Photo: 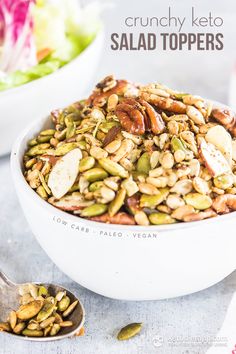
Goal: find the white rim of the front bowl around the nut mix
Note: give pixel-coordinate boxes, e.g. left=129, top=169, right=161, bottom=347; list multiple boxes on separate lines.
left=11, top=103, right=236, bottom=233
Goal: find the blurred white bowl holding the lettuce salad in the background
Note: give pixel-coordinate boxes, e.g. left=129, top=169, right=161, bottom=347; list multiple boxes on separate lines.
left=0, top=32, right=104, bottom=156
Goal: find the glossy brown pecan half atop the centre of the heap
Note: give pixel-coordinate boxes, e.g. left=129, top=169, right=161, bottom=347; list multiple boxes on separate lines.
left=115, top=98, right=165, bottom=135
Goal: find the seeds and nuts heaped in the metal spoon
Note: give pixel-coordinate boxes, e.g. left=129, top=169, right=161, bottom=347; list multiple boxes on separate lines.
left=0, top=284, right=79, bottom=337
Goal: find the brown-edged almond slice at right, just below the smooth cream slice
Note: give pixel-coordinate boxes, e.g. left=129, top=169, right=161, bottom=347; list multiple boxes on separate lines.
left=199, top=139, right=231, bottom=177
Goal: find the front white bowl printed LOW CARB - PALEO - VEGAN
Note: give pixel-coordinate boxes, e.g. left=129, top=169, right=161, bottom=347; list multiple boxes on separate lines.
left=11, top=118, right=236, bottom=300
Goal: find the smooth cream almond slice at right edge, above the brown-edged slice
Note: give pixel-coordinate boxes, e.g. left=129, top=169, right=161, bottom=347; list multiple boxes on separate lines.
left=205, top=125, right=233, bottom=165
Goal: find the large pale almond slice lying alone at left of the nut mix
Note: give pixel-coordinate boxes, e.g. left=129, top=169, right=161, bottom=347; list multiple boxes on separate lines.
left=48, top=148, right=82, bottom=199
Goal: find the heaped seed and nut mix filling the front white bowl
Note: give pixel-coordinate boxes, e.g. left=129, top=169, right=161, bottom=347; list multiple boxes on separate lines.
left=24, top=75, right=236, bottom=226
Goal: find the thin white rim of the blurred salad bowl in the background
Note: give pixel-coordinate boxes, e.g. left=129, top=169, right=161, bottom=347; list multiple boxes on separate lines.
left=0, top=28, right=104, bottom=98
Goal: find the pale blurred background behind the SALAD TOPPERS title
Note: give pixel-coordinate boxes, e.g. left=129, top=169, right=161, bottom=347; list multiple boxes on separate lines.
left=87, top=0, right=236, bottom=103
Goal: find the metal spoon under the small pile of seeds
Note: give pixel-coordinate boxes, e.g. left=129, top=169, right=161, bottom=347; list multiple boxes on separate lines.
left=0, top=271, right=85, bottom=342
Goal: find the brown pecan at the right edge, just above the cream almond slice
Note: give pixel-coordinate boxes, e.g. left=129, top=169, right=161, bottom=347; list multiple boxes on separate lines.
left=211, top=108, right=236, bottom=137
